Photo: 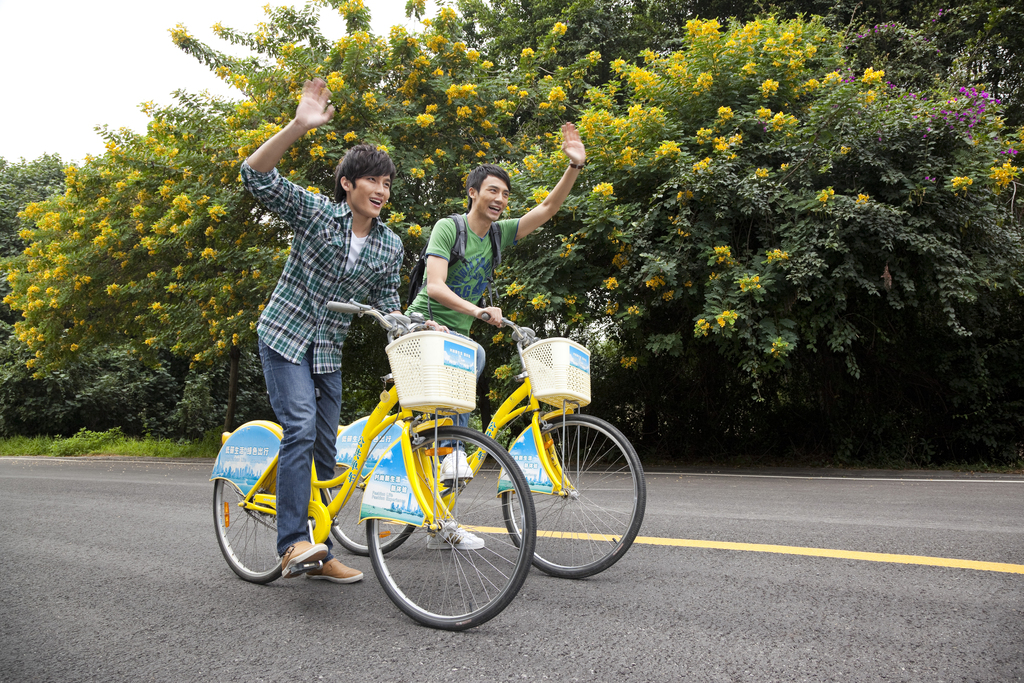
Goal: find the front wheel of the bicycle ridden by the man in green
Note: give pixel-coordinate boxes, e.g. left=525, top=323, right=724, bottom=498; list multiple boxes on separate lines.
left=503, top=415, right=647, bottom=579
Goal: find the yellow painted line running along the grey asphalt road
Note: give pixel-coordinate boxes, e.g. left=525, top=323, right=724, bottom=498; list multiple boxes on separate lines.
left=469, top=526, right=1024, bottom=573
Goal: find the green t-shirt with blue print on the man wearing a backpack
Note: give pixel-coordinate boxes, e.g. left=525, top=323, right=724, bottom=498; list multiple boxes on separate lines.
left=408, top=216, right=519, bottom=336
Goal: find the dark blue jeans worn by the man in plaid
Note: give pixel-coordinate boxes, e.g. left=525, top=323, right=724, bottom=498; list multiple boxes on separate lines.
left=259, top=341, right=341, bottom=561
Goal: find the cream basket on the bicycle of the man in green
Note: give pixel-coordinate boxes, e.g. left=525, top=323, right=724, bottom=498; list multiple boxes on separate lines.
left=522, top=337, right=590, bottom=408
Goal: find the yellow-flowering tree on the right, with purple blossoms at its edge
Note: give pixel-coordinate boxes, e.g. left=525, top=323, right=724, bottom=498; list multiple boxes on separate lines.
left=487, top=18, right=1024, bottom=462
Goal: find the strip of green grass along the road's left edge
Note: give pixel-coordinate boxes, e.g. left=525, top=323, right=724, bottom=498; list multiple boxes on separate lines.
left=0, top=428, right=220, bottom=458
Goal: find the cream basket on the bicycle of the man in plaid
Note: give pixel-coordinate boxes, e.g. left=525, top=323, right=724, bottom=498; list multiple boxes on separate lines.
left=385, top=331, right=476, bottom=413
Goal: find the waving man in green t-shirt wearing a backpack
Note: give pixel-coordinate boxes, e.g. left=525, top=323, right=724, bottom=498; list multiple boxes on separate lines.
left=409, top=123, right=587, bottom=489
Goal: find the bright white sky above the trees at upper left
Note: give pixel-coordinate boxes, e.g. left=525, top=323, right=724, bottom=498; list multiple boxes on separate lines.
left=0, top=0, right=435, bottom=162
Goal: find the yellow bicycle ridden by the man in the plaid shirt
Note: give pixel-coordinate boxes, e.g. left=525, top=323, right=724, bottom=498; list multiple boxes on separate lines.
left=211, top=302, right=537, bottom=631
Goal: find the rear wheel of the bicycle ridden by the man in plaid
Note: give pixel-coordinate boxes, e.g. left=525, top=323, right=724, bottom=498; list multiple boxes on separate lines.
left=213, top=479, right=281, bottom=584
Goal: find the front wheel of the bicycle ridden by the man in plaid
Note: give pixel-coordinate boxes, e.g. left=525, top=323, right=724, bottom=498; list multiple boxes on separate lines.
left=366, top=427, right=536, bottom=631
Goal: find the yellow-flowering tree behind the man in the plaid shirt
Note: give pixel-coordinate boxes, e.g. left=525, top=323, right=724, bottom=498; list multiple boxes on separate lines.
left=5, top=1, right=564, bottom=421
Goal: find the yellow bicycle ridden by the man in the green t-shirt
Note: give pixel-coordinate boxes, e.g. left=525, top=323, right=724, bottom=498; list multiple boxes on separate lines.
left=333, top=318, right=647, bottom=579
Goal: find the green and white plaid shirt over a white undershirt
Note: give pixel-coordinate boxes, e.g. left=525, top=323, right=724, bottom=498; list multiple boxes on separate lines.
left=242, top=163, right=404, bottom=374
